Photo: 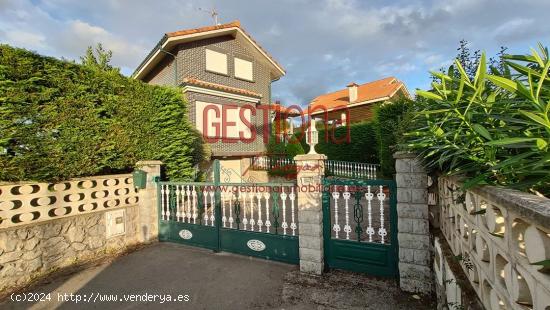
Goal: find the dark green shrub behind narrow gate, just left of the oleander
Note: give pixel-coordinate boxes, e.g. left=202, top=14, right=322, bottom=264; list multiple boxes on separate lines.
left=375, top=98, right=413, bottom=177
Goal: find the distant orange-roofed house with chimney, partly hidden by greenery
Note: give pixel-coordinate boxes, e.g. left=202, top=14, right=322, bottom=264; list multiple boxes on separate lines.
left=308, top=77, right=411, bottom=125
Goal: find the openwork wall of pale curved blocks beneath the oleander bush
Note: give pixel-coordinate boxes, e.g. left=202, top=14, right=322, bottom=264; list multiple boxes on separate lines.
left=440, top=177, right=550, bottom=310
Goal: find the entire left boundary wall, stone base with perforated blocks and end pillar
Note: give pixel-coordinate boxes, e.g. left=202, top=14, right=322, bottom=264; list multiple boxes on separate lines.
left=0, top=167, right=162, bottom=296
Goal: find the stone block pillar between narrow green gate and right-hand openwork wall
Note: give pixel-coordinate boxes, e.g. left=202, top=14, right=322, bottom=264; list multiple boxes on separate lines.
left=393, top=152, right=433, bottom=294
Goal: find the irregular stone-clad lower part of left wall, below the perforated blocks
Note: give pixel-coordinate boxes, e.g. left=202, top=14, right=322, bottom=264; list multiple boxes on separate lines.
left=0, top=206, right=139, bottom=294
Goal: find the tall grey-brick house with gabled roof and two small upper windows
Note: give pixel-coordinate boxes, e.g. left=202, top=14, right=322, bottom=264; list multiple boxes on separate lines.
left=133, top=21, right=285, bottom=182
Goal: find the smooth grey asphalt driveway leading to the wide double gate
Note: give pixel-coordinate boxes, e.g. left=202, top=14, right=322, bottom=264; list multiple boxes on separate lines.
left=0, top=243, right=297, bottom=309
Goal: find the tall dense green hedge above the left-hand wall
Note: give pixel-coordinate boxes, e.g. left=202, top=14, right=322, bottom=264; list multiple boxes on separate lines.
left=0, top=45, right=204, bottom=181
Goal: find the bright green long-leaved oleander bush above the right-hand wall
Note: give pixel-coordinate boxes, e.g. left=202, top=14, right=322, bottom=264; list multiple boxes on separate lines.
left=403, top=45, right=550, bottom=195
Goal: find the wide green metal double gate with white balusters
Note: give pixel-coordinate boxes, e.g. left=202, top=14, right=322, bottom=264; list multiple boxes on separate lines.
left=158, top=160, right=299, bottom=264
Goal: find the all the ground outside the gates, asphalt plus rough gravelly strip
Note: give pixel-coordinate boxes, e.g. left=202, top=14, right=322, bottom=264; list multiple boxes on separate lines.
left=0, top=243, right=434, bottom=310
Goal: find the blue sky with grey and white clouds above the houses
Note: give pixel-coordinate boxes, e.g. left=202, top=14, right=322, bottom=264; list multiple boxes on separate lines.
left=0, top=0, right=550, bottom=106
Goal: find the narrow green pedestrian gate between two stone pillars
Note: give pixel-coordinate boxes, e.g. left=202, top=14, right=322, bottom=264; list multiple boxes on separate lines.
left=323, top=178, right=399, bottom=277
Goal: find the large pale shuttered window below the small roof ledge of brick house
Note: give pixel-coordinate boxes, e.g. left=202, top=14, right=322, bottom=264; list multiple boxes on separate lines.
left=195, top=101, right=252, bottom=139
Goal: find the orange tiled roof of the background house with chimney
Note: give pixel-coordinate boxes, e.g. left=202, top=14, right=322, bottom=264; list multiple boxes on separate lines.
left=309, top=77, right=408, bottom=113
